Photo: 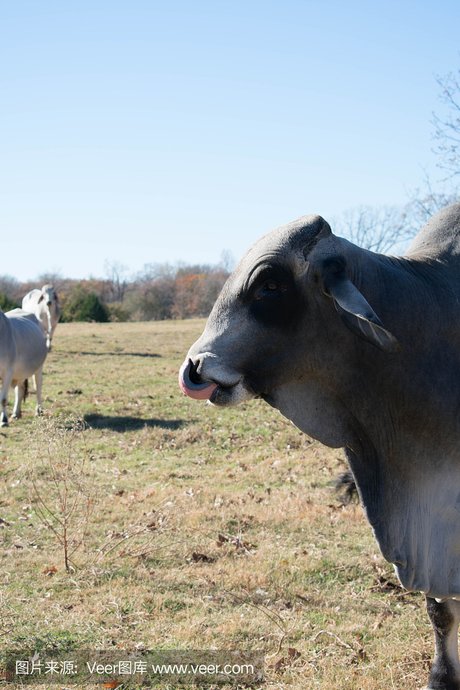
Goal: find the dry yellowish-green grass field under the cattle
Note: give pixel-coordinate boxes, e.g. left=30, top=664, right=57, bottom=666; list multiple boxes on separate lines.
left=0, top=321, right=432, bottom=690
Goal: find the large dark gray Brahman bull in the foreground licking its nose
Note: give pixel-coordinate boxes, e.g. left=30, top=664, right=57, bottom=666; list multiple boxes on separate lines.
left=179, top=204, right=460, bottom=690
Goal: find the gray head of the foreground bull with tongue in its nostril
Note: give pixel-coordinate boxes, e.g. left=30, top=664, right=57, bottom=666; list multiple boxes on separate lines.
left=179, top=216, right=397, bottom=445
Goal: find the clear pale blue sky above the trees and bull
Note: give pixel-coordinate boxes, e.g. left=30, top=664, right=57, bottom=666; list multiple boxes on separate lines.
left=0, top=0, right=460, bottom=279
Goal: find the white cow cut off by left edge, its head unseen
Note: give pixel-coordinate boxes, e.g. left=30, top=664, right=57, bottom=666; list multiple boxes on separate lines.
left=0, top=309, right=48, bottom=426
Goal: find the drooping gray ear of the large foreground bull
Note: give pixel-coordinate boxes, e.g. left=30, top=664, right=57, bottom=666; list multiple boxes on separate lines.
left=322, top=257, right=400, bottom=352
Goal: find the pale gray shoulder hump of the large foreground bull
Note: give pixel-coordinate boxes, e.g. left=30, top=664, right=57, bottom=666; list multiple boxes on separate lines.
left=407, top=203, right=460, bottom=261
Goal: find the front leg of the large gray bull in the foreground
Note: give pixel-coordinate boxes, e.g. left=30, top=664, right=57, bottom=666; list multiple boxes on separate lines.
left=426, top=597, right=460, bottom=690
